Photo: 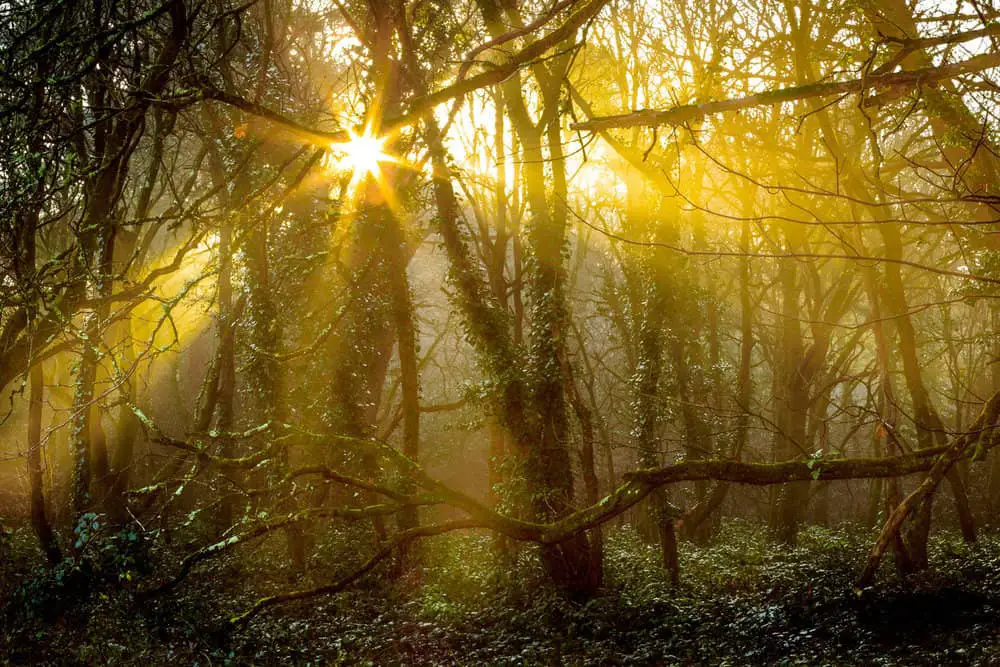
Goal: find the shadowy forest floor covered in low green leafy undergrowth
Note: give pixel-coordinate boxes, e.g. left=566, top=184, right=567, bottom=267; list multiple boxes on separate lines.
left=0, top=522, right=1000, bottom=665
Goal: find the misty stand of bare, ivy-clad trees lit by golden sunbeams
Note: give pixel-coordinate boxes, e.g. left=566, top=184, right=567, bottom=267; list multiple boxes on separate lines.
left=0, top=0, right=1000, bottom=622
